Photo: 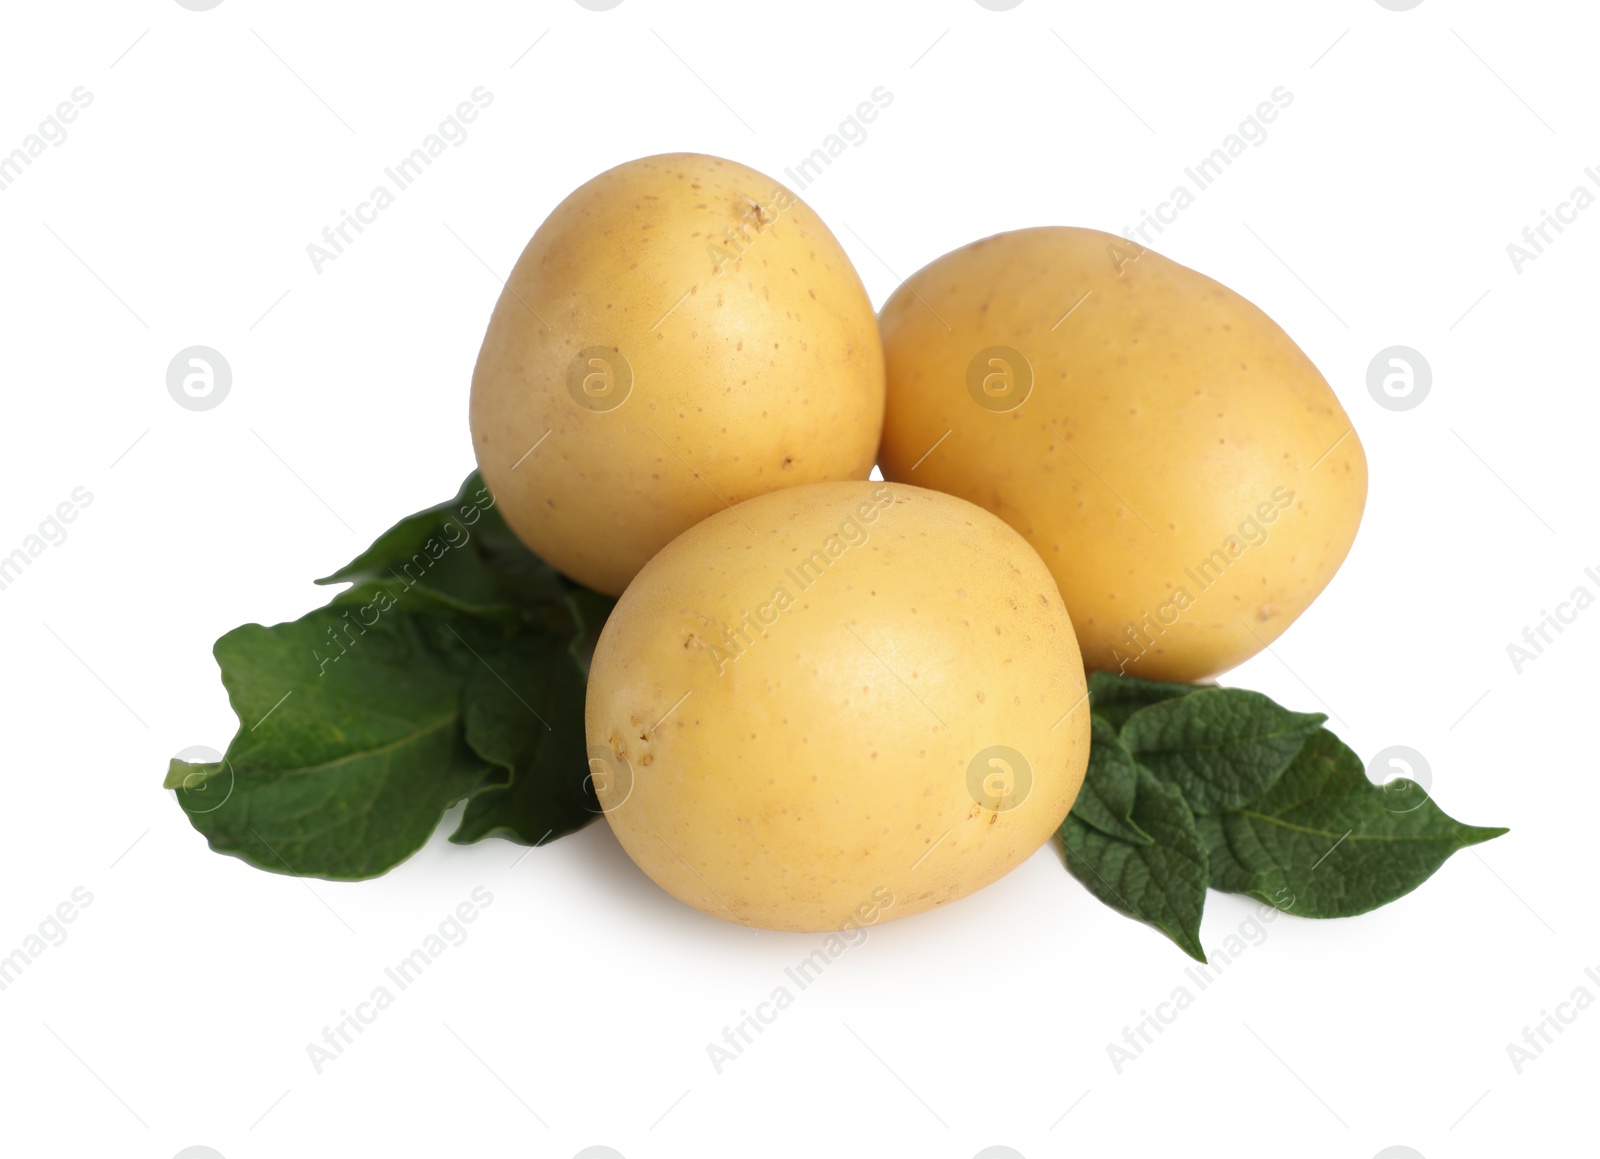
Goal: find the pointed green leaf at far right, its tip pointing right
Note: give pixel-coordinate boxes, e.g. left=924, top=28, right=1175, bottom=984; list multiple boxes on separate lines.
left=1202, top=728, right=1506, bottom=917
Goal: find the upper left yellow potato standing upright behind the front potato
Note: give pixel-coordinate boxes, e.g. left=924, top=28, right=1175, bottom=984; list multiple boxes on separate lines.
left=472, top=154, right=883, bottom=596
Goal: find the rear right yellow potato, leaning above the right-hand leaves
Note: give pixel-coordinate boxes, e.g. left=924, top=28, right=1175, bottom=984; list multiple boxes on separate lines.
left=880, top=227, right=1366, bottom=680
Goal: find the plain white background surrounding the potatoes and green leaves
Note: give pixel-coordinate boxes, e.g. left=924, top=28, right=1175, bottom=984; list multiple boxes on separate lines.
left=0, top=0, right=1600, bottom=1159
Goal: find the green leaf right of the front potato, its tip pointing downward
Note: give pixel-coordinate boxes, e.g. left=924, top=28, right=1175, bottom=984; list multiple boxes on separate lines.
left=1061, top=768, right=1208, bottom=962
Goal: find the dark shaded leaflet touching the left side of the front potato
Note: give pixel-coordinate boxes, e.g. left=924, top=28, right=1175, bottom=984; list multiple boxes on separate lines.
left=451, top=634, right=600, bottom=845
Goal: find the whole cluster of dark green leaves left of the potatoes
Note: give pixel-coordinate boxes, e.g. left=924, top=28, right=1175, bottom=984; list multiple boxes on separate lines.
left=166, top=474, right=614, bottom=879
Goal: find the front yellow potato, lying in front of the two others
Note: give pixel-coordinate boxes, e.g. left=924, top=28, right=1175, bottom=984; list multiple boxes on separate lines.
left=586, top=482, right=1090, bottom=930
